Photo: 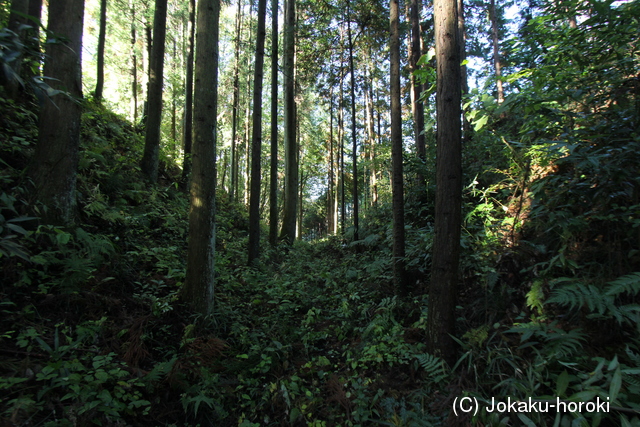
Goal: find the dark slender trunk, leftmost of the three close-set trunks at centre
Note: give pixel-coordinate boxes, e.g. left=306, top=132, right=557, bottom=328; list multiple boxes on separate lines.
left=249, top=0, right=267, bottom=265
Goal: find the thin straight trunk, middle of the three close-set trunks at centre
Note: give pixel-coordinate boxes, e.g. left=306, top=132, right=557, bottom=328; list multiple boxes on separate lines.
left=269, top=0, right=278, bottom=246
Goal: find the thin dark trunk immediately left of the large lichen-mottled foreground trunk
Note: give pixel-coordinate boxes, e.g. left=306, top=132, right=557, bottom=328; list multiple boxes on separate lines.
left=182, top=0, right=196, bottom=188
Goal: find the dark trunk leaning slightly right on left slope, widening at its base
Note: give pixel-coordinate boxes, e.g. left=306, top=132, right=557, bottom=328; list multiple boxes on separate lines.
left=140, top=0, right=167, bottom=184
